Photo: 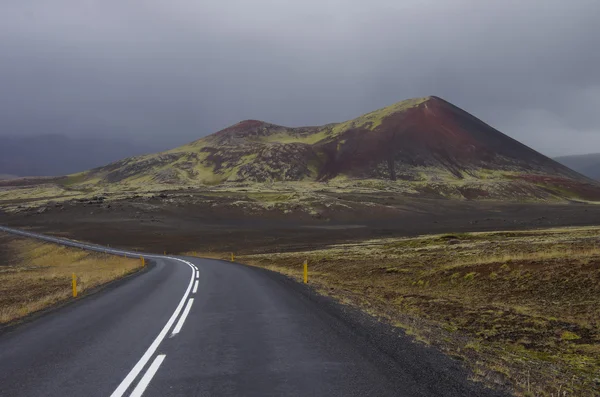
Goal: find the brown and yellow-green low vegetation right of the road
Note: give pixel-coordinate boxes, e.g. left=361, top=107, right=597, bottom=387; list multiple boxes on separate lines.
left=202, top=228, right=600, bottom=396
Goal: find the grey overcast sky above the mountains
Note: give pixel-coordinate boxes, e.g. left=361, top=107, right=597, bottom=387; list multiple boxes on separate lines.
left=0, top=0, right=600, bottom=155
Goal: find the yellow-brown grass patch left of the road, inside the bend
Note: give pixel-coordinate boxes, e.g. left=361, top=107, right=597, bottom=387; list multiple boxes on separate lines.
left=0, top=233, right=141, bottom=324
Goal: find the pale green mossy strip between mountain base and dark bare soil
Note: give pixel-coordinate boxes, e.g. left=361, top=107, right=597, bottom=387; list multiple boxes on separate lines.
left=0, top=173, right=598, bottom=218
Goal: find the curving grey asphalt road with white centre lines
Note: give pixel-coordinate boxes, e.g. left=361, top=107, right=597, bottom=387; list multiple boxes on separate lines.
left=0, top=227, right=506, bottom=397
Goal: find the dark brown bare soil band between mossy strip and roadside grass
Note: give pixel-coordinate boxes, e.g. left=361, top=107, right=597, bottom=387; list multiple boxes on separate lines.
left=0, top=192, right=600, bottom=253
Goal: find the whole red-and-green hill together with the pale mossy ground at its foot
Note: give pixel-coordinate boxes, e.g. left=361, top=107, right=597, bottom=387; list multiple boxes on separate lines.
left=1, top=96, right=600, bottom=200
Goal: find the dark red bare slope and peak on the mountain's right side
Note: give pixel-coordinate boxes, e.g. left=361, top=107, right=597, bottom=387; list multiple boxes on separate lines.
left=320, top=97, right=585, bottom=180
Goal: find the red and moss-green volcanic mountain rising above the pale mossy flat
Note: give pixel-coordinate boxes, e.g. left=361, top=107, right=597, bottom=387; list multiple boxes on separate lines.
left=74, top=96, right=591, bottom=184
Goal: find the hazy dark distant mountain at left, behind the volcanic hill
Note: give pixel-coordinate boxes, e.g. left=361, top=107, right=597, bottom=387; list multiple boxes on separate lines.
left=0, top=134, right=162, bottom=176
